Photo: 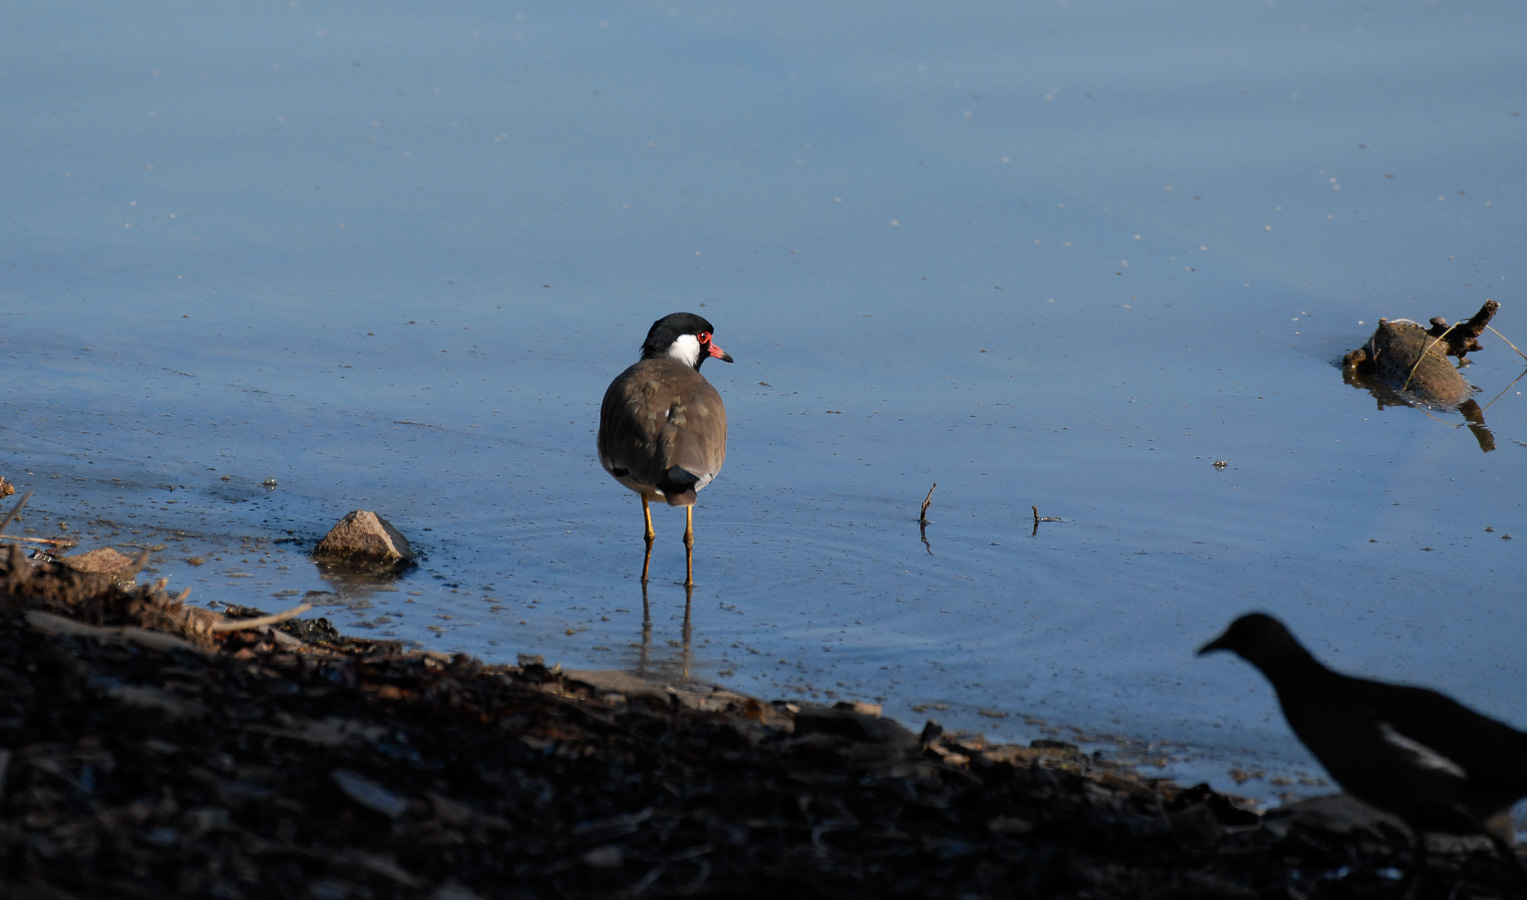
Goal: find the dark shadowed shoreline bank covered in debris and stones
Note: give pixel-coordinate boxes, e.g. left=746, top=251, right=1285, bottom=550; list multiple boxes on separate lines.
left=0, top=549, right=1512, bottom=900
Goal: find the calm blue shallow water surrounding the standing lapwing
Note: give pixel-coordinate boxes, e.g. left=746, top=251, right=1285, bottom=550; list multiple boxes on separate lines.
left=0, top=3, right=1527, bottom=795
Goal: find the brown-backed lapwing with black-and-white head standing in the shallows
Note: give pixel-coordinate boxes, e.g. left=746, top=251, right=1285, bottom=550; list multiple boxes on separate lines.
left=599, top=313, right=731, bottom=587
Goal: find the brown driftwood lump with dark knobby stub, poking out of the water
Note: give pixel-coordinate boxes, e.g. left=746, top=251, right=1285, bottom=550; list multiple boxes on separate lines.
left=1342, top=299, right=1501, bottom=406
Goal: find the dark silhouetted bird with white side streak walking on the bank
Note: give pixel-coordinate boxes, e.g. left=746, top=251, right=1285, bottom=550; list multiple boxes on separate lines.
left=1199, top=613, right=1527, bottom=888
